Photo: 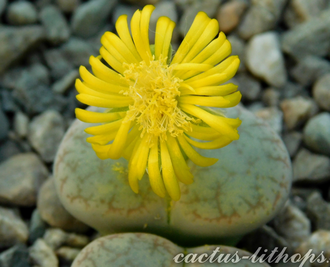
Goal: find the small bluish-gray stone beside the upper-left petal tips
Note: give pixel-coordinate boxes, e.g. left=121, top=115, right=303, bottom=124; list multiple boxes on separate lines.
left=61, top=37, right=98, bottom=67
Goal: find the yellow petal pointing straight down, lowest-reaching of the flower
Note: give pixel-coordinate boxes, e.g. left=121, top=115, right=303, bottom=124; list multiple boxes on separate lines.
left=160, top=142, right=181, bottom=201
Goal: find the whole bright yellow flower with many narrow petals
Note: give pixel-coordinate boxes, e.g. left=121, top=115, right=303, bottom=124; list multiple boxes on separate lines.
left=76, top=5, right=241, bottom=200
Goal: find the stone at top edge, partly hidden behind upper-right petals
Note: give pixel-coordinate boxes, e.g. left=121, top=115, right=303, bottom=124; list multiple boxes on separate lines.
left=179, top=0, right=222, bottom=36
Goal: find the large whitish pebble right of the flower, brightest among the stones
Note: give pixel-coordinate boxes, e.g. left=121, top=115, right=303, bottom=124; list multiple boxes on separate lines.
left=246, top=32, right=287, bottom=87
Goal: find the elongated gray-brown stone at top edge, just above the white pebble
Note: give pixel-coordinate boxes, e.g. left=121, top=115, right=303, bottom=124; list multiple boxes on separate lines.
left=238, top=0, right=287, bottom=39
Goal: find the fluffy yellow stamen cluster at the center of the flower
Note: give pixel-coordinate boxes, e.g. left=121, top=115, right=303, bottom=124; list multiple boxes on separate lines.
left=124, top=59, right=193, bottom=142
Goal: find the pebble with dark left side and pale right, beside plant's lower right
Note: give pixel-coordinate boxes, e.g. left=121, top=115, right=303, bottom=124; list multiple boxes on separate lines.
left=274, top=203, right=311, bottom=248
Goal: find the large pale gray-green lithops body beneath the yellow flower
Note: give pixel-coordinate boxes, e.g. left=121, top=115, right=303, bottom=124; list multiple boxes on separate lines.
left=54, top=104, right=292, bottom=245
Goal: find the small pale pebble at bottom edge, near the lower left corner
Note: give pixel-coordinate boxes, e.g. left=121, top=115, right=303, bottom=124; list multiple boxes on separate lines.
left=30, top=238, right=59, bottom=267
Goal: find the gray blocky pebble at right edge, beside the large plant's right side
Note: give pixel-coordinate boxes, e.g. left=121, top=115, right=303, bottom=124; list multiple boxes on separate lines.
left=293, top=148, right=330, bottom=183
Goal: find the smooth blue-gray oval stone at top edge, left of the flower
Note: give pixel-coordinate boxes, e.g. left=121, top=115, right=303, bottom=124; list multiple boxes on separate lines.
left=71, top=0, right=117, bottom=38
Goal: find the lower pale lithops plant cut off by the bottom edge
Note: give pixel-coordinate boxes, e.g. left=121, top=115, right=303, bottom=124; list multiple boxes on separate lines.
left=72, top=233, right=269, bottom=267
